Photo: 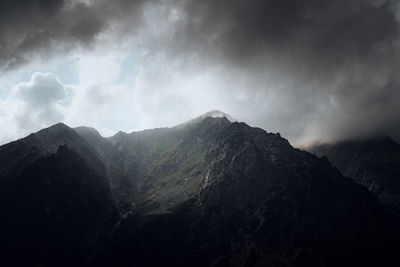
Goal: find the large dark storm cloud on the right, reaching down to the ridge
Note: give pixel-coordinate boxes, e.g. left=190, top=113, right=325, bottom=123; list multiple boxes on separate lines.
left=163, top=0, right=400, bottom=144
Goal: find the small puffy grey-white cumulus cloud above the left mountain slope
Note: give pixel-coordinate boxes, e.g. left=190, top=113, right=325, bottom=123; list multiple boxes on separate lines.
left=0, top=72, right=75, bottom=143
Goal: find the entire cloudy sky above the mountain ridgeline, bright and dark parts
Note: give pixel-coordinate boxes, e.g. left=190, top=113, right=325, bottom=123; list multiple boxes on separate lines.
left=0, top=0, right=400, bottom=146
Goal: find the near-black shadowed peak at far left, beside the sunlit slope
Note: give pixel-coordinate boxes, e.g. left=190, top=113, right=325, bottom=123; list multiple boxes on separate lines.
left=0, top=125, right=119, bottom=266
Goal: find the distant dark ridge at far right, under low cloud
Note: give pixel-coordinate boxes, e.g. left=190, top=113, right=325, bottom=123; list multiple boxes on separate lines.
left=311, top=137, right=400, bottom=215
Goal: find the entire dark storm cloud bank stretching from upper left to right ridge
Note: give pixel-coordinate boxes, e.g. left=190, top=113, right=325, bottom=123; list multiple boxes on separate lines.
left=0, top=0, right=400, bottom=142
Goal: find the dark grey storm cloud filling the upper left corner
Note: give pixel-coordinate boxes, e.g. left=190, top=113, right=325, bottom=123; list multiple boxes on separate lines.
left=0, top=0, right=148, bottom=70
